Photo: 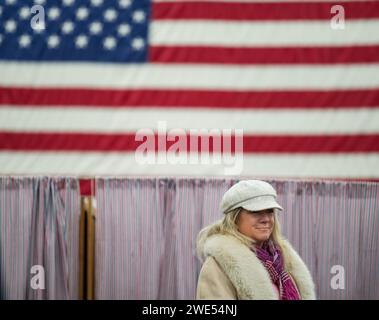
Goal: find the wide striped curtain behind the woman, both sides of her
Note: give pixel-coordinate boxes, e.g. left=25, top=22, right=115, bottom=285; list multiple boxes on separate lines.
left=95, top=178, right=379, bottom=299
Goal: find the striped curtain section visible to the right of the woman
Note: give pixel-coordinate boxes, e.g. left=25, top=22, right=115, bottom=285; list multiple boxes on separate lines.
left=270, top=181, right=379, bottom=300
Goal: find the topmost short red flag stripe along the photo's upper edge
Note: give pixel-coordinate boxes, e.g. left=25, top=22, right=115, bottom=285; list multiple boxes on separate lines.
left=152, top=1, right=379, bottom=20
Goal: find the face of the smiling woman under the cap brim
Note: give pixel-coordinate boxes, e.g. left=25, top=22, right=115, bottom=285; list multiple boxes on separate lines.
left=237, top=209, right=275, bottom=245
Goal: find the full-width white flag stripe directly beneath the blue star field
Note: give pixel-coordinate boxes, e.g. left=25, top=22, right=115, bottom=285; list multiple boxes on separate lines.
left=0, top=62, right=379, bottom=90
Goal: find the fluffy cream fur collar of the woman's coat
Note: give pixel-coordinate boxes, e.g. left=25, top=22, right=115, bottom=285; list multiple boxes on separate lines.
left=204, top=234, right=315, bottom=300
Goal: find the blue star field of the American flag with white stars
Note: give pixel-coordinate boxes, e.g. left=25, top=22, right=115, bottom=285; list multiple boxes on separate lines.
left=0, top=0, right=151, bottom=63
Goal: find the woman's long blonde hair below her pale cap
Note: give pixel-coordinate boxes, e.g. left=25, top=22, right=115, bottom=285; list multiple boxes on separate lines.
left=197, top=208, right=284, bottom=260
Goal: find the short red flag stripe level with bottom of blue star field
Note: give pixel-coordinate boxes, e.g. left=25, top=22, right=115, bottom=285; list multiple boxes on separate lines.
left=150, top=46, right=379, bottom=64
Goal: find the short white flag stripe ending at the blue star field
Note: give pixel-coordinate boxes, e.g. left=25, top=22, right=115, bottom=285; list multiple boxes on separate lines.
left=150, top=16, right=379, bottom=47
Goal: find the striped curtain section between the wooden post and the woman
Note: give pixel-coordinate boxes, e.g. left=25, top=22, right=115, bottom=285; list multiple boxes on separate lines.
left=95, top=179, right=230, bottom=299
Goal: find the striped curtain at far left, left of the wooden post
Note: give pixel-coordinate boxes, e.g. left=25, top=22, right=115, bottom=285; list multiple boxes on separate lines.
left=0, top=177, right=80, bottom=300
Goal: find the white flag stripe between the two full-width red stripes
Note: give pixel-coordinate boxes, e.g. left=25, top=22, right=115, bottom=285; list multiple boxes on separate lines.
left=0, top=106, right=379, bottom=135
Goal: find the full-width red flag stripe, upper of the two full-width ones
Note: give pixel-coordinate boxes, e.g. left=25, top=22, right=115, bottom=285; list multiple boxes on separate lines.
left=0, top=87, right=379, bottom=109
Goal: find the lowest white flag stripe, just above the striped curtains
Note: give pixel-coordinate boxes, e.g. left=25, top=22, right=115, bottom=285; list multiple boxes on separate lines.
left=0, top=152, right=379, bottom=178
